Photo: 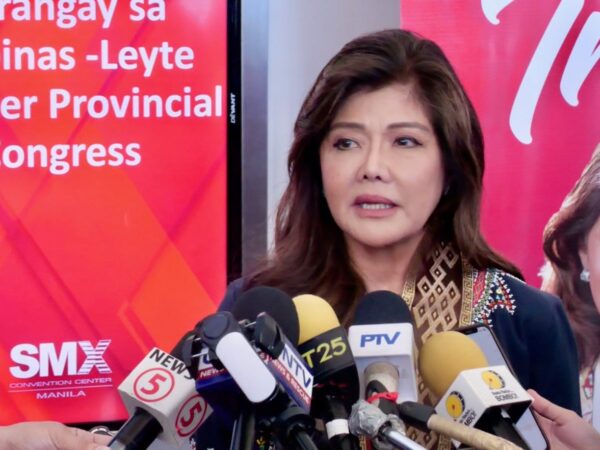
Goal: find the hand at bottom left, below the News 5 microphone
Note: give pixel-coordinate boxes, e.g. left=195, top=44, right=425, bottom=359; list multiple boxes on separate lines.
left=0, top=422, right=110, bottom=450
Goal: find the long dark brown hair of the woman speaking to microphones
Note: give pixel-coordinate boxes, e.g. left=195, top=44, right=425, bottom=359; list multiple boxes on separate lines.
left=249, top=30, right=520, bottom=318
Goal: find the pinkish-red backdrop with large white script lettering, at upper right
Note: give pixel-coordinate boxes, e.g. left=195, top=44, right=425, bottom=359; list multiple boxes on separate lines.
left=401, top=0, right=600, bottom=285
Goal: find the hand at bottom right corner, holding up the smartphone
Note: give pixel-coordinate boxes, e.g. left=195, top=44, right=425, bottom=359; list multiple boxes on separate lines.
left=527, top=389, right=600, bottom=450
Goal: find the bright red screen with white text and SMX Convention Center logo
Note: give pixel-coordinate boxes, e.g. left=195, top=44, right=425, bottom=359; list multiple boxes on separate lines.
left=0, top=0, right=227, bottom=424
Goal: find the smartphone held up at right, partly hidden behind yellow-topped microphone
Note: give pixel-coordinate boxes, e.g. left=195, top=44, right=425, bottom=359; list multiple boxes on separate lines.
left=457, top=324, right=550, bottom=450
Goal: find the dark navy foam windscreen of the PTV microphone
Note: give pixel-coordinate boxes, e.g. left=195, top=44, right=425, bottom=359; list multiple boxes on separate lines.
left=352, top=291, right=412, bottom=325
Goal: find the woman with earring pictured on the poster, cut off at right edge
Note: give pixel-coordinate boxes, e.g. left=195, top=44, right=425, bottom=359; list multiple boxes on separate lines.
left=542, top=146, right=600, bottom=430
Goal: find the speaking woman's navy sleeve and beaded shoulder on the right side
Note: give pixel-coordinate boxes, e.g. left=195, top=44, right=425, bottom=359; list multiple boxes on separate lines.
left=473, top=269, right=580, bottom=413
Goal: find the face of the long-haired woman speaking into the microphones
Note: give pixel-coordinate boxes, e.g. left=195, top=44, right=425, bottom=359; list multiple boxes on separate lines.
left=320, top=83, right=444, bottom=253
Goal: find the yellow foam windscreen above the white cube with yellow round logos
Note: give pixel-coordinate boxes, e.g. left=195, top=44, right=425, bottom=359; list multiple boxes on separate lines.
left=419, top=331, right=489, bottom=397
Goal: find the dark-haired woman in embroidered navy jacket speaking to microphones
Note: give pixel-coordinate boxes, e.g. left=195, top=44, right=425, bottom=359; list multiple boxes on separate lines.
left=221, top=30, right=579, bottom=448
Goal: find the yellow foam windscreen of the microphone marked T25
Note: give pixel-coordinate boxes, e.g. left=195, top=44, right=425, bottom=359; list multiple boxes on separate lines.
left=292, top=294, right=340, bottom=345
